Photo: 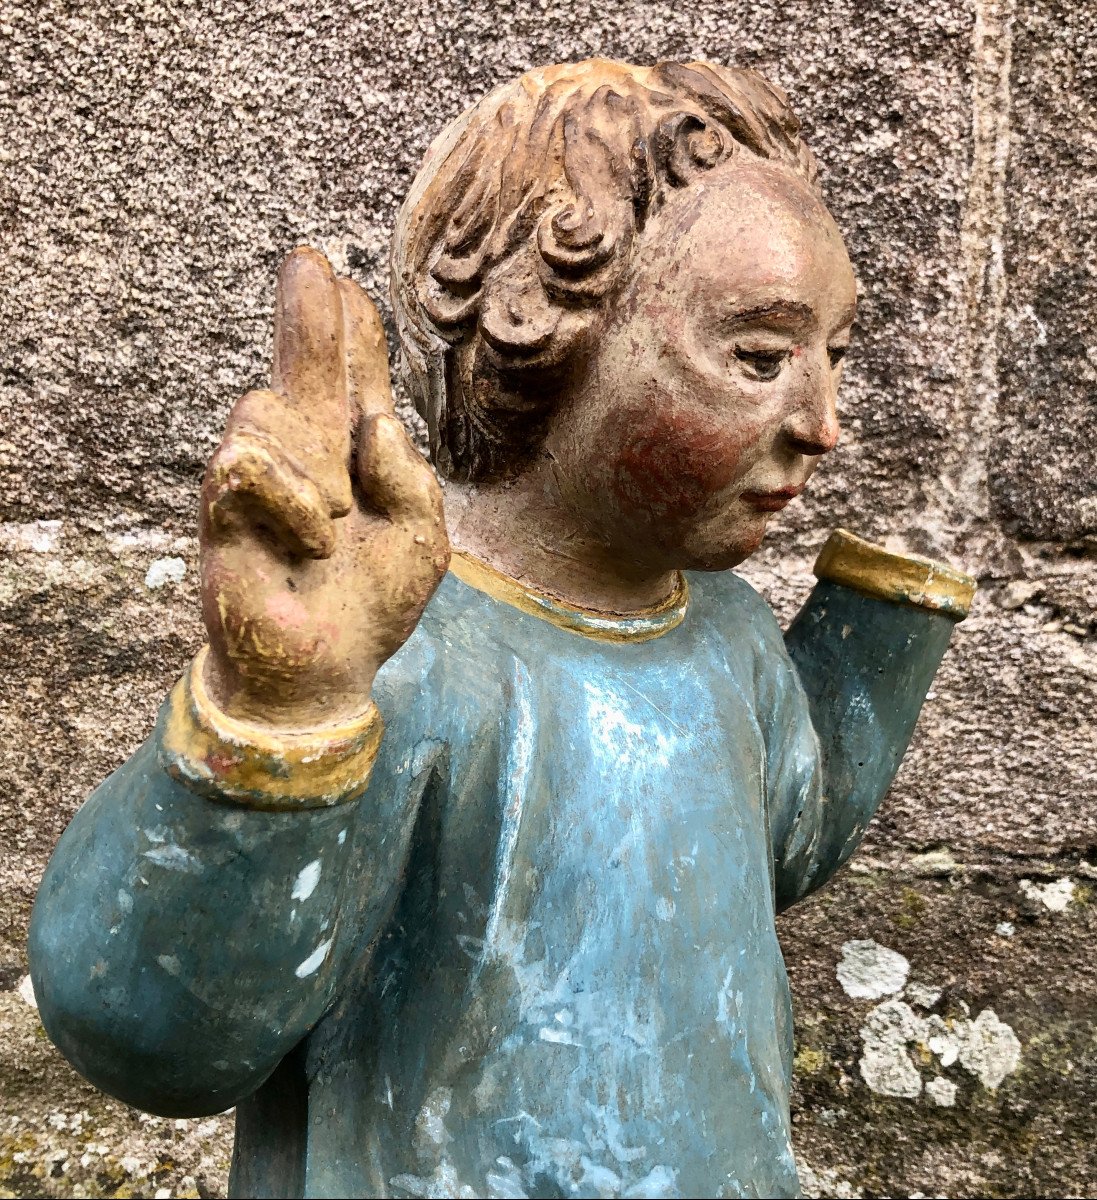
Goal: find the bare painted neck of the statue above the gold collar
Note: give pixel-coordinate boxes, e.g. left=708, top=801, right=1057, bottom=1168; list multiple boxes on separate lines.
left=445, top=462, right=677, bottom=613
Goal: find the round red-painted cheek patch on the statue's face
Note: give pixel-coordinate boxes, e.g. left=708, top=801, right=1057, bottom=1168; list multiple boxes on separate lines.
left=604, top=397, right=750, bottom=516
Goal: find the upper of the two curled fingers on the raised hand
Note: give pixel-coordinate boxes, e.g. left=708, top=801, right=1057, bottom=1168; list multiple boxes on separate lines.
left=224, top=390, right=353, bottom=517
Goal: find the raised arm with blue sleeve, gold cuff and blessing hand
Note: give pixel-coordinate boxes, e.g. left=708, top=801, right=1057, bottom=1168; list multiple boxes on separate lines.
left=29, top=250, right=448, bottom=1115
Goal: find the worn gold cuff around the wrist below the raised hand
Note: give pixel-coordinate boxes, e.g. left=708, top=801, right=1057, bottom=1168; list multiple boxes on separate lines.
left=160, top=647, right=384, bottom=811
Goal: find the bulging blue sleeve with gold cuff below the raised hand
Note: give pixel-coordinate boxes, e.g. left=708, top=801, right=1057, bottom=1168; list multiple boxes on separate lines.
left=29, top=647, right=430, bottom=1116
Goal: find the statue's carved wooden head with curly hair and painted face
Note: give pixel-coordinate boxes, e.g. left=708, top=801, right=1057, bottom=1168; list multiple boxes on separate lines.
left=392, top=59, right=856, bottom=566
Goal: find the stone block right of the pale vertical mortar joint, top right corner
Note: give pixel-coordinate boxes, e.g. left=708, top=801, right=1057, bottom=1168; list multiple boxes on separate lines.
left=991, top=4, right=1097, bottom=540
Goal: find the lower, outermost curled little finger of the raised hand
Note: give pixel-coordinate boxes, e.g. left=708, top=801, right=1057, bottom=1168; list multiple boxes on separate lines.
left=203, top=433, right=335, bottom=558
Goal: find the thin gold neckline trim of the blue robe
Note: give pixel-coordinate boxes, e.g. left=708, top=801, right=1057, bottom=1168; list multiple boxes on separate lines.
left=450, top=551, right=689, bottom=642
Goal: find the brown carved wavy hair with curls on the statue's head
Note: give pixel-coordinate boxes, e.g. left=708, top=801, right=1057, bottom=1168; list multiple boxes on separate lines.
left=392, top=59, right=816, bottom=480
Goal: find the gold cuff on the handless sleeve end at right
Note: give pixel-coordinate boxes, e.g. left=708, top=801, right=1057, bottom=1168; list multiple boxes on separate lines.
left=815, top=529, right=978, bottom=620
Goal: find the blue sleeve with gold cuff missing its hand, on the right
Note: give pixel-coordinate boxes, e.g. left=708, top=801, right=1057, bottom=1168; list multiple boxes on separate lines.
left=767, top=530, right=976, bottom=908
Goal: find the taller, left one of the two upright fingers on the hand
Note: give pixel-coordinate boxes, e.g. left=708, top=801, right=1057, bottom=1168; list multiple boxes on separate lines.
left=271, top=246, right=349, bottom=432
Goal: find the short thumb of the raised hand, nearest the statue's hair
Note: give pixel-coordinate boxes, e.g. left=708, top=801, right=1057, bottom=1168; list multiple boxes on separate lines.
left=358, top=413, right=443, bottom=526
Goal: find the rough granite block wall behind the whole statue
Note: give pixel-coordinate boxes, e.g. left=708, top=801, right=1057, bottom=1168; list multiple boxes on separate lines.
left=0, top=0, right=1097, bottom=1196
